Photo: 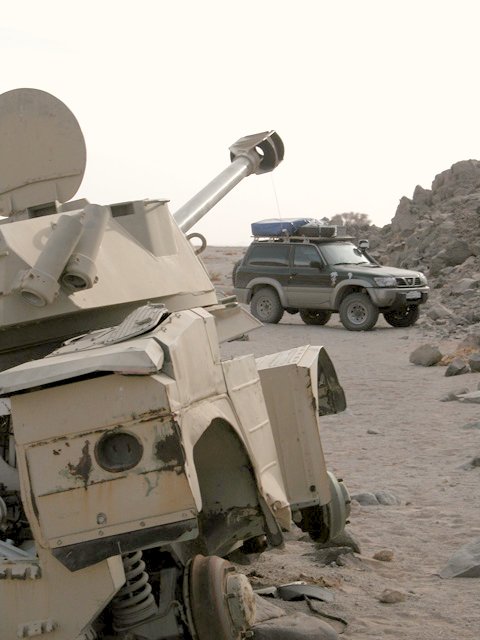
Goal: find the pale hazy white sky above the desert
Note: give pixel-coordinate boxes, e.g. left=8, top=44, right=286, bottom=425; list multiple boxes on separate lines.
left=0, top=0, right=480, bottom=245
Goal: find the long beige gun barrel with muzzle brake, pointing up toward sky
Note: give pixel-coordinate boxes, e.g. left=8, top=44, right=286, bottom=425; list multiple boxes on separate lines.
left=173, top=131, right=284, bottom=233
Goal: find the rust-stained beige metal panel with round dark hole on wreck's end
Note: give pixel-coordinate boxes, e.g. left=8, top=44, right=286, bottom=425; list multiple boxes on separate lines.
left=20, top=419, right=196, bottom=547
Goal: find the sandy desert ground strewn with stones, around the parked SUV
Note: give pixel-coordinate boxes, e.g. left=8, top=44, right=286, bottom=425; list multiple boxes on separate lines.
left=202, top=247, right=480, bottom=640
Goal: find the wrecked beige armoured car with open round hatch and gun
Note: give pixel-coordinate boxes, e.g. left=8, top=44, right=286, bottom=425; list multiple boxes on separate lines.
left=0, top=89, right=349, bottom=640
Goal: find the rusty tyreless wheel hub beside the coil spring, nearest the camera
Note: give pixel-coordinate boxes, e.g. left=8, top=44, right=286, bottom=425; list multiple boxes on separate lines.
left=184, top=555, right=255, bottom=640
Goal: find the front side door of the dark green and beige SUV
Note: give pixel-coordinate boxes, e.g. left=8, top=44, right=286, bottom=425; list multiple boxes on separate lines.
left=285, top=244, right=332, bottom=309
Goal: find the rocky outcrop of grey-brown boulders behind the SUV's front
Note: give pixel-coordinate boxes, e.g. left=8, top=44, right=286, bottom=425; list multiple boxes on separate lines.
left=370, top=160, right=480, bottom=334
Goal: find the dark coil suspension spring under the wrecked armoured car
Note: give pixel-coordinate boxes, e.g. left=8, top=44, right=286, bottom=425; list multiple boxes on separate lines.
left=112, top=551, right=158, bottom=631
